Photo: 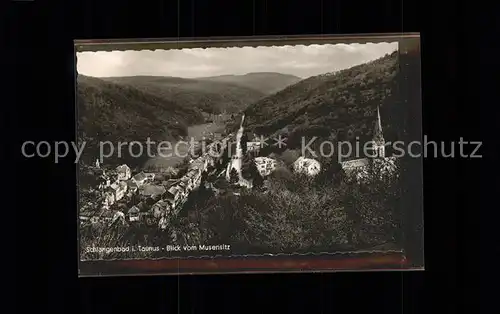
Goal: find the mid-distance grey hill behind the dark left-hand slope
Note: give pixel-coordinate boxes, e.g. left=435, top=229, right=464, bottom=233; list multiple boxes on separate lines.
left=102, top=76, right=266, bottom=114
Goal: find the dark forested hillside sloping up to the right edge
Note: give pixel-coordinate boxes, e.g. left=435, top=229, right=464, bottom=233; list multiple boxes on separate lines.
left=238, top=52, right=401, bottom=153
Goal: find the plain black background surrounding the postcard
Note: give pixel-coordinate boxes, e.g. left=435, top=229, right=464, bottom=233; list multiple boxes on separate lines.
left=7, top=0, right=482, bottom=313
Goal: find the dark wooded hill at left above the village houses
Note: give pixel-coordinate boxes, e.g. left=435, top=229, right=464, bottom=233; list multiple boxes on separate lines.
left=77, top=75, right=203, bottom=167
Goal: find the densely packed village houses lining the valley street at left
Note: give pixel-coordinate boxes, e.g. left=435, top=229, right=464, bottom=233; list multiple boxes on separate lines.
left=76, top=113, right=286, bottom=229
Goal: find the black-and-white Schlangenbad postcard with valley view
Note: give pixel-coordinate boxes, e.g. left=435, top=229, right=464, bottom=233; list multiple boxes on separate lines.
left=75, top=34, right=424, bottom=276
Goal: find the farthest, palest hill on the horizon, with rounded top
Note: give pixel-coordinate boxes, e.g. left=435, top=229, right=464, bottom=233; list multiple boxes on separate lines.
left=199, top=72, right=301, bottom=95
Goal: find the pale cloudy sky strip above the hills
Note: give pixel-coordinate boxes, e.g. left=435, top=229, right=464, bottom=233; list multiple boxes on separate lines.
left=77, top=42, right=398, bottom=78
